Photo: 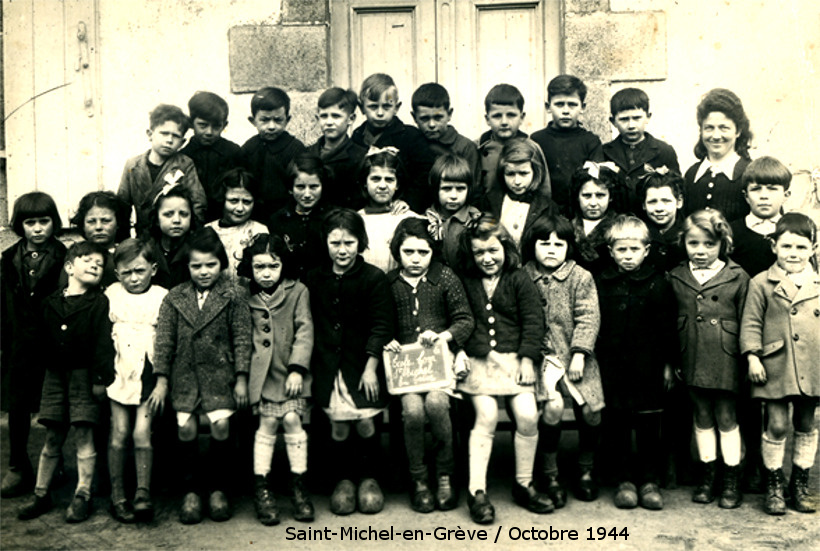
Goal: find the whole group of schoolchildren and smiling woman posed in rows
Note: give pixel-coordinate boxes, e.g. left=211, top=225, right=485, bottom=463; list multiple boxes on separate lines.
left=2, top=74, right=820, bottom=525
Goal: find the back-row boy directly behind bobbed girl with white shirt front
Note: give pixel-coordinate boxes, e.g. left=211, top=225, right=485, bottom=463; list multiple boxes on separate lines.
left=477, top=84, right=552, bottom=197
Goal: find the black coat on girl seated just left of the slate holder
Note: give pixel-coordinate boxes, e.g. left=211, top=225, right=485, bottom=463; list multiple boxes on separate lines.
left=305, top=256, right=395, bottom=408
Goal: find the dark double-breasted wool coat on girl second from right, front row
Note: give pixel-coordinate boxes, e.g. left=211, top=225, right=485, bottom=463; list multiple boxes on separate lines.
left=669, top=260, right=749, bottom=392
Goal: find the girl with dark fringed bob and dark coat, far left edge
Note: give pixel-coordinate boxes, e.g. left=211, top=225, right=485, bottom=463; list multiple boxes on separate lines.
left=0, top=191, right=66, bottom=497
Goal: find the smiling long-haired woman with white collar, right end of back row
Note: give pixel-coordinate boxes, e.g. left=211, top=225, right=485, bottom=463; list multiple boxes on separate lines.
left=683, top=88, right=752, bottom=220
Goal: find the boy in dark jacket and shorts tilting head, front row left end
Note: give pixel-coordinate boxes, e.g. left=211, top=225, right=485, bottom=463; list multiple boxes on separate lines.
left=17, top=241, right=115, bottom=523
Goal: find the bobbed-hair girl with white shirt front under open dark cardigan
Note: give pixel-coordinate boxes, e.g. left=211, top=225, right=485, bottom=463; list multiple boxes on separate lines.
left=480, top=139, right=556, bottom=246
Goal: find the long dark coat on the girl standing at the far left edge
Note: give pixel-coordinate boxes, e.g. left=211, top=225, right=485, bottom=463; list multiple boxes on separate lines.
left=0, top=238, right=66, bottom=412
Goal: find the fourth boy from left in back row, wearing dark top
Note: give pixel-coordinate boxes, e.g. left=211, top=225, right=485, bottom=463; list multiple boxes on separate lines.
left=308, top=87, right=367, bottom=209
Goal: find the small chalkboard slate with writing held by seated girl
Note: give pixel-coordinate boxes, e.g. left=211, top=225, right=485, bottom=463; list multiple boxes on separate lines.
left=384, top=340, right=453, bottom=394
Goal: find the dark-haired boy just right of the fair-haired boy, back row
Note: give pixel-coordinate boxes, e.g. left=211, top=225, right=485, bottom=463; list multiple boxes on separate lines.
left=410, top=82, right=481, bottom=183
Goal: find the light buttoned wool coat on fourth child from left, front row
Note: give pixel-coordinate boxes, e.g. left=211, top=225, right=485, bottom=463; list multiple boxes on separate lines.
left=248, top=279, right=313, bottom=404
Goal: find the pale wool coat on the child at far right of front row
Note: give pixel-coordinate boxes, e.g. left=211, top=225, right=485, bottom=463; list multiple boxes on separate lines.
left=740, top=264, right=820, bottom=400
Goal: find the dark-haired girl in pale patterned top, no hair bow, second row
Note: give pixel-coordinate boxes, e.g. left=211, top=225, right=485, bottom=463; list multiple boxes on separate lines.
left=205, top=168, right=268, bottom=282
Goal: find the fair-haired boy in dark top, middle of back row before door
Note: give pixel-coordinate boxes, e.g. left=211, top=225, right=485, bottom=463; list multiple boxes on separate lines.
left=351, top=73, right=435, bottom=212
